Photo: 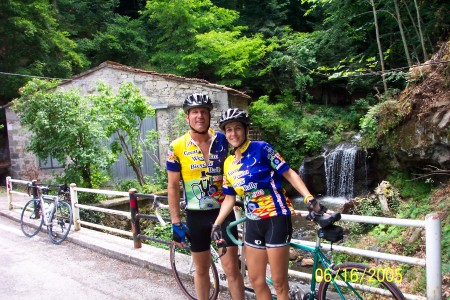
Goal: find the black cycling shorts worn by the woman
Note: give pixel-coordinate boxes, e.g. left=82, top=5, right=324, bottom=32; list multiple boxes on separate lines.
left=245, top=215, right=292, bottom=249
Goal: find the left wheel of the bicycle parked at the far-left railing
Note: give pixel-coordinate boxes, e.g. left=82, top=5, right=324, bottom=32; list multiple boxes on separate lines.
left=20, top=199, right=44, bottom=237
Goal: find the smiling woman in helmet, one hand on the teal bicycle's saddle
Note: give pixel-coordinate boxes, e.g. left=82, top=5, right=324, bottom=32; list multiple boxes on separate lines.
left=211, top=108, right=320, bottom=300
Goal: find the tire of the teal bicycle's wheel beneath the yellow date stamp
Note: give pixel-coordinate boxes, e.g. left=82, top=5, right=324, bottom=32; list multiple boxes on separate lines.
left=318, top=263, right=405, bottom=300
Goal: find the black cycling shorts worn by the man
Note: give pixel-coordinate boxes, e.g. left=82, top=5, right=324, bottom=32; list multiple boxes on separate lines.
left=186, top=209, right=238, bottom=252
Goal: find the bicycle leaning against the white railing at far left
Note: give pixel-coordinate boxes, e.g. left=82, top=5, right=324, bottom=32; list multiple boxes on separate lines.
left=20, top=182, right=73, bottom=244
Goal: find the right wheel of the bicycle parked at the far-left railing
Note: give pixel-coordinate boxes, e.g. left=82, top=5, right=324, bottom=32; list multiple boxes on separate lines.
left=47, top=201, right=73, bottom=244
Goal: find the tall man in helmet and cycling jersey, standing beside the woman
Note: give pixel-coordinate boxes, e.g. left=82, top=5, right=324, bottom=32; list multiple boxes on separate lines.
left=166, top=94, right=244, bottom=299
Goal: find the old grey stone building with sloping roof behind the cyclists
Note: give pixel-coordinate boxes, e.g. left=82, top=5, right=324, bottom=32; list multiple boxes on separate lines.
left=6, top=61, right=250, bottom=180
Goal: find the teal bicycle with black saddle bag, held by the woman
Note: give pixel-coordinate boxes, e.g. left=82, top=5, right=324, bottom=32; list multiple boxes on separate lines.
left=226, top=211, right=405, bottom=300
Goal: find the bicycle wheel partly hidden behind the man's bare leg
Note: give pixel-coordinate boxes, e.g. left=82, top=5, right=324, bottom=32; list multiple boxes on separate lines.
left=170, top=243, right=219, bottom=300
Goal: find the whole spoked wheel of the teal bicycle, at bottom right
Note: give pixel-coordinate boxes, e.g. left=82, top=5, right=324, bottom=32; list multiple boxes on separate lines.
left=318, top=263, right=405, bottom=300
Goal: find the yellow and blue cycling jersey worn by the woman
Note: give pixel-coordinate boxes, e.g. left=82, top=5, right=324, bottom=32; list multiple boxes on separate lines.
left=223, top=140, right=294, bottom=220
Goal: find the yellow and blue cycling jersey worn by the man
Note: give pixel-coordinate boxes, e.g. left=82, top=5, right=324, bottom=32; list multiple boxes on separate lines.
left=166, top=129, right=228, bottom=210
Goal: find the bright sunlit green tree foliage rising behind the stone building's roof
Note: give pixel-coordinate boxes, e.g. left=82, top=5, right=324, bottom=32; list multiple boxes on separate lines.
left=143, top=0, right=265, bottom=84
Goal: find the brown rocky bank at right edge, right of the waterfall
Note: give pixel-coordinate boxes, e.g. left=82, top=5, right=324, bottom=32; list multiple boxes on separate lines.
left=395, top=41, right=450, bottom=171
